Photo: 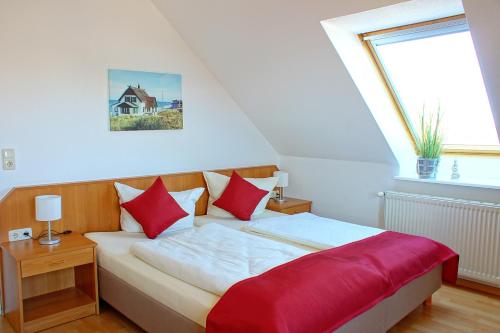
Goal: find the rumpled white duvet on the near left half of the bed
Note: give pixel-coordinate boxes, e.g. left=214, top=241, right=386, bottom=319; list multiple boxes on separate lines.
left=130, top=223, right=310, bottom=295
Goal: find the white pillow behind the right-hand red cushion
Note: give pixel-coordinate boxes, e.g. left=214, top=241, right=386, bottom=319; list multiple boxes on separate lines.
left=203, top=171, right=278, bottom=217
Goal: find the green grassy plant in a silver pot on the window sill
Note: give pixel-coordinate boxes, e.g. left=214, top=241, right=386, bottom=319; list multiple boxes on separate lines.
left=415, top=107, right=443, bottom=179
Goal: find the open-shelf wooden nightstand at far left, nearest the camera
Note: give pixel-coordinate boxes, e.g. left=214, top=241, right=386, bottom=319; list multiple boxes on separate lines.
left=1, top=234, right=99, bottom=332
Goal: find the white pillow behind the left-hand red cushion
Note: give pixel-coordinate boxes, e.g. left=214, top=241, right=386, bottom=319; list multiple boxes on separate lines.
left=115, top=182, right=205, bottom=232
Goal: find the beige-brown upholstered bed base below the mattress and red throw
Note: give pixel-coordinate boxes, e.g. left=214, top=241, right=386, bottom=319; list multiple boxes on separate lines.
left=99, top=266, right=441, bottom=333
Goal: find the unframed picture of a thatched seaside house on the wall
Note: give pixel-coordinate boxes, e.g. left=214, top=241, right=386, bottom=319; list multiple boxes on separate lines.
left=108, top=69, right=183, bottom=131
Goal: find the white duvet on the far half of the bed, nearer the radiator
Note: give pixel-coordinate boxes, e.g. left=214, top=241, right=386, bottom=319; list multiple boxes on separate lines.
left=243, top=213, right=384, bottom=250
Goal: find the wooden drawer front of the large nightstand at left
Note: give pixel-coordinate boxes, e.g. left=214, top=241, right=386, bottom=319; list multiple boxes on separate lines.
left=21, top=248, right=94, bottom=278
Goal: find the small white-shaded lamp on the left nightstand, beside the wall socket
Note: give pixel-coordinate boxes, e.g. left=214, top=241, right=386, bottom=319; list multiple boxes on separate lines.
left=35, top=195, right=61, bottom=245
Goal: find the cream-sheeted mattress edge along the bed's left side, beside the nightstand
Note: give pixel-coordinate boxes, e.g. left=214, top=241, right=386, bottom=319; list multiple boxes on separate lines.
left=85, top=230, right=219, bottom=327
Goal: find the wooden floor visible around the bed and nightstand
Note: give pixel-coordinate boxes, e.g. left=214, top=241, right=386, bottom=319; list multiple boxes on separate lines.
left=0, top=286, right=500, bottom=333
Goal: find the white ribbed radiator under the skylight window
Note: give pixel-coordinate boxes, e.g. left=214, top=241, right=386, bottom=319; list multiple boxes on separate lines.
left=384, top=192, right=500, bottom=287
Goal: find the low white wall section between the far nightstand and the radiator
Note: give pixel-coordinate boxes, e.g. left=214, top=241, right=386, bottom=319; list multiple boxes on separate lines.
left=280, top=156, right=396, bottom=227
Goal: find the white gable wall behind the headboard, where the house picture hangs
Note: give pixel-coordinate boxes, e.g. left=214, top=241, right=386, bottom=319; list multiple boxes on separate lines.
left=0, top=0, right=277, bottom=198
